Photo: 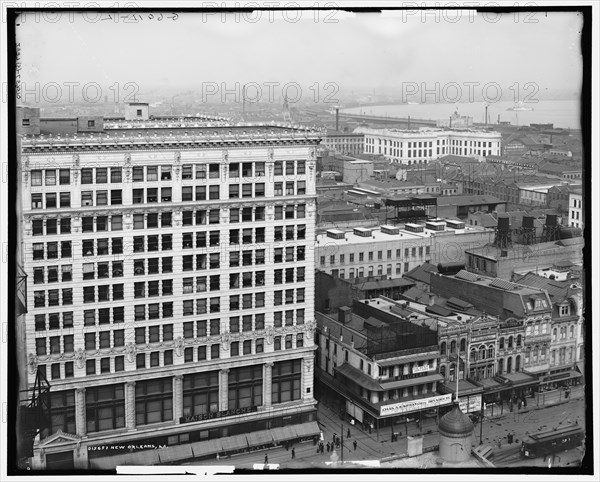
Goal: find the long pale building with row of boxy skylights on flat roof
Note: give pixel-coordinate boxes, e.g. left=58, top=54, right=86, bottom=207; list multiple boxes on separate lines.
left=315, top=220, right=494, bottom=278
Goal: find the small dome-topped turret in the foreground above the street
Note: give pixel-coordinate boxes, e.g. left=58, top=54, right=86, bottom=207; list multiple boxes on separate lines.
left=438, top=403, right=473, bottom=462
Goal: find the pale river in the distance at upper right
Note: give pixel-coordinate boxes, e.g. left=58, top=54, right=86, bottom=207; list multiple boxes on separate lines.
left=341, top=99, right=581, bottom=129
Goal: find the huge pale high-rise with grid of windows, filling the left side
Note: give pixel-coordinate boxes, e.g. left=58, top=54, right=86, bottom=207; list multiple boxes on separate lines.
left=20, top=114, right=320, bottom=469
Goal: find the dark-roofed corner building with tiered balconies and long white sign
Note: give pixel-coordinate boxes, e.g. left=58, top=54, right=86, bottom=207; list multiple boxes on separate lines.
left=315, top=299, right=452, bottom=434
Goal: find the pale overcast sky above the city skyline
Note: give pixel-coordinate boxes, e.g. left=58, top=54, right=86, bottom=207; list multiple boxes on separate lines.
left=17, top=11, right=582, bottom=97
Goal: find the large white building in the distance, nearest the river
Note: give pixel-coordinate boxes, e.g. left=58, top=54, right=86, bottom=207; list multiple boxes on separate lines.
left=355, top=127, right=502, bottom=166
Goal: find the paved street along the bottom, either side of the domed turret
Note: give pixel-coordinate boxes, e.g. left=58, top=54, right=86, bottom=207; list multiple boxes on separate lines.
left=180, top=387, right=585, bottom=469
